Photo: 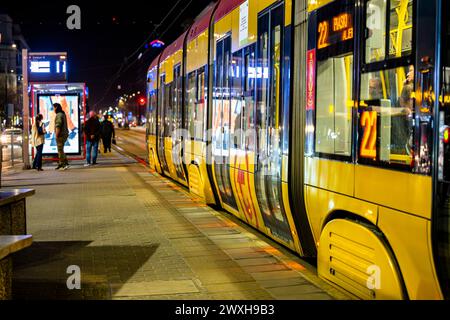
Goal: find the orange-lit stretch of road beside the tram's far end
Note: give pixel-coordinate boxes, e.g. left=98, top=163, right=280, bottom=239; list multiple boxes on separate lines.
left=116, top=128, right=148, bottom=163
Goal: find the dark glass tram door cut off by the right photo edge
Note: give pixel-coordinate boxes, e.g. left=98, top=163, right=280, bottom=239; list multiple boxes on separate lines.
left=433, top=1, right=450, bottom=299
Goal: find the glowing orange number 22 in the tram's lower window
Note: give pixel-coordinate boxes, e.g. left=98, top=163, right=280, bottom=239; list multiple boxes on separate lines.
left=360, top=111, right=378, bottom=159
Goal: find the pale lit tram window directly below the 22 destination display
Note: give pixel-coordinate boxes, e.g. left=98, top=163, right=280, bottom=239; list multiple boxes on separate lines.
left=315, top=55, right=353, bottom=157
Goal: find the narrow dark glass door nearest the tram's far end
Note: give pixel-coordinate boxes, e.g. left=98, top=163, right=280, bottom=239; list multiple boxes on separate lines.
left=158, top=74, right=170, bottom=175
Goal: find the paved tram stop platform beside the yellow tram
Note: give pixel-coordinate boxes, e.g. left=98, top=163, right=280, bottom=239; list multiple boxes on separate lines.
left=2, top=150, right=348, bottom=300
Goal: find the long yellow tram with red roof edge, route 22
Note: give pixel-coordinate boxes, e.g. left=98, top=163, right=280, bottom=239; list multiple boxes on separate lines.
left=147, top=0, right=450, bottom=299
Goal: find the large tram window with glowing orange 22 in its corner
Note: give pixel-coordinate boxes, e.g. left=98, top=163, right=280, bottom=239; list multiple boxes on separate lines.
left=359, top=66, right=414, bottom=166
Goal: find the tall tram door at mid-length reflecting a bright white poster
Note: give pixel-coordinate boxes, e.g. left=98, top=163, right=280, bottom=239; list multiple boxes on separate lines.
left=212, top=36, right=238, bottom=211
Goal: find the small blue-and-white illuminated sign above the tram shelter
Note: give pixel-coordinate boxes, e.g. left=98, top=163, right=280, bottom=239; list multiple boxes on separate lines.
left=28, top=53, right=67, bottom=82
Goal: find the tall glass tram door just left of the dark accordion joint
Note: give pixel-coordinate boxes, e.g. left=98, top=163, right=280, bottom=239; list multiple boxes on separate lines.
left=255, top=4, right=292, bottom=242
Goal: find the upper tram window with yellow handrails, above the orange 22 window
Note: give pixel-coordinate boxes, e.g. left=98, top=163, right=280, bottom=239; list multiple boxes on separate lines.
left=365, top=0, right=413, bottom=63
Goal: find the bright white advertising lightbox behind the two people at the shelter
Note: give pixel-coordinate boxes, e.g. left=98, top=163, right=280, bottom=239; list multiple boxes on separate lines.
left=37, top=94, right=81, bottom=155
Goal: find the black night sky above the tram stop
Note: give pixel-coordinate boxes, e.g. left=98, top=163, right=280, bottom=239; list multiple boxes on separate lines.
left=0, top=0, right=212, bottom=110
